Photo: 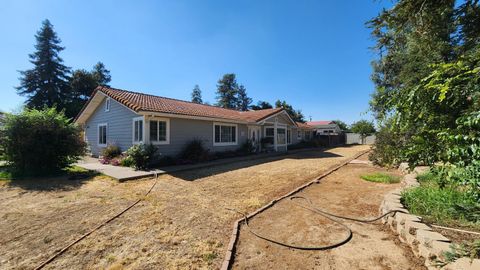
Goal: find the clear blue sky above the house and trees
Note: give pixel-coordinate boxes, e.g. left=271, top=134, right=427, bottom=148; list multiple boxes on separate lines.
left=0, top=0, right=390, bottom=123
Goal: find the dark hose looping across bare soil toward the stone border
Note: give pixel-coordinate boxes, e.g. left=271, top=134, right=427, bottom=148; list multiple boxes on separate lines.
left=226, top=196, right=405, bottom=250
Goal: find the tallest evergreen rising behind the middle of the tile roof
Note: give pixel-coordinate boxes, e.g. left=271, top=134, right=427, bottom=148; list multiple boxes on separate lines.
left=217, top=73, right=238, bottom=109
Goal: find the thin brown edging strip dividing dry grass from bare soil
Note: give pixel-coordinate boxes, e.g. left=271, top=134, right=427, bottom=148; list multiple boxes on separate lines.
left=220, top=150, right=370, bottom=270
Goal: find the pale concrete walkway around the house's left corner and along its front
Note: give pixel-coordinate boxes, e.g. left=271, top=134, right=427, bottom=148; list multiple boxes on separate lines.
left=75, top=148, right=308, bottom=181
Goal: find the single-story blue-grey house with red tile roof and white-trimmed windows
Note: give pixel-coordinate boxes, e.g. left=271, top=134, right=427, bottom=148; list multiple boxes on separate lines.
left=75, top=86, right=312, bottom=156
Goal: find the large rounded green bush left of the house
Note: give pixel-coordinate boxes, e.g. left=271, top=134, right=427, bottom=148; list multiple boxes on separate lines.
left=0, top=108, right=86, bottom=175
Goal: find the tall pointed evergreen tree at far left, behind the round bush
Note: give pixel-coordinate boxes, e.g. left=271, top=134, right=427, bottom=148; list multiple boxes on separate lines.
left=16, top=20, right=70, bottom=110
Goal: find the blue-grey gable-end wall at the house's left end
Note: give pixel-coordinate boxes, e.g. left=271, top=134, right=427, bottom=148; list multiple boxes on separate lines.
left=85, top=98, right=139, bottom=156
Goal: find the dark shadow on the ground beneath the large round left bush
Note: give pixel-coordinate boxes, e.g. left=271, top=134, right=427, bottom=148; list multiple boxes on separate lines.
left=4, top=171, right=99, bottom=191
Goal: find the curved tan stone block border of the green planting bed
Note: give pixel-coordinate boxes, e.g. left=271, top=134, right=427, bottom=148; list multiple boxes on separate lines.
left=380, top=164, right=480, bottom=270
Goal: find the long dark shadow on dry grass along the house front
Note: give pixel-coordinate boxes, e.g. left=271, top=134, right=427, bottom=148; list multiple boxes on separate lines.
left=169, top=150, right=342, bottom=181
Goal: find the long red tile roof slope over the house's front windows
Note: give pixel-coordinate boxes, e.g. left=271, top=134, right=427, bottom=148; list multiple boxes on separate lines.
left=92, top=86, right=283, bottom=122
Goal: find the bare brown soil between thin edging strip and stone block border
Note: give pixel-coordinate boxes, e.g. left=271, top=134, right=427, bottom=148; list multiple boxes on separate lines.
left=233, top=155, right=426, bottom=269
